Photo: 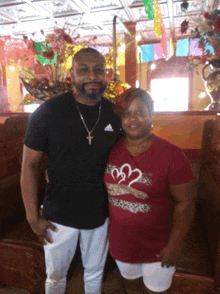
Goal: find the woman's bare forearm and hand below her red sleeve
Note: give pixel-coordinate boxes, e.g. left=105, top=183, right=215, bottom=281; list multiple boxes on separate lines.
left=159, top=182, right=194, bottom=267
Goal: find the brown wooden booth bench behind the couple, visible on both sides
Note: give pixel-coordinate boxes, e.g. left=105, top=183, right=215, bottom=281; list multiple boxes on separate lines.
left=0, top=112, right=220, bottom=294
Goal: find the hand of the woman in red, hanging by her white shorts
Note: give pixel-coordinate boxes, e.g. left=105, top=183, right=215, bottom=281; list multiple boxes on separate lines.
left=158, top=244, right=182, bottom=267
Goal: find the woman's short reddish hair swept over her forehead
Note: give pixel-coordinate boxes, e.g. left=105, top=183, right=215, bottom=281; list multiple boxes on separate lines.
left=114, top=88, right=154, bottom=117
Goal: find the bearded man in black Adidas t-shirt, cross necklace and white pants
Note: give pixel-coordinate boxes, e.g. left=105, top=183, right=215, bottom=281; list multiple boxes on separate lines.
left=21, top=48, right=120, bottom=294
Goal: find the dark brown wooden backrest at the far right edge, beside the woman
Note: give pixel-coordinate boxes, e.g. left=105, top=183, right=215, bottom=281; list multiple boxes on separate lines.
left=198, top=117, right=220, bottom=293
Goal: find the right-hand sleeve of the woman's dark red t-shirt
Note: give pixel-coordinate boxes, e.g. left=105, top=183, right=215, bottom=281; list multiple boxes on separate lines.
left=168, top=148, right=193, bottom=186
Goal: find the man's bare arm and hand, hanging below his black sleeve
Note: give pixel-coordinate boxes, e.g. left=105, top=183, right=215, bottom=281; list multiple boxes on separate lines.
left=21, top=145, right=56, bottom=244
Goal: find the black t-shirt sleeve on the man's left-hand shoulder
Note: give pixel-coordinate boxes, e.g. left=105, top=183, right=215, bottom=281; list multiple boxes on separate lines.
left=24, top=104, right=47, bottom=151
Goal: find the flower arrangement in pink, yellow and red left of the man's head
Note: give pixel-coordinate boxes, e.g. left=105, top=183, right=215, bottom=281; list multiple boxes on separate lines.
left=20, top=29, right=86, bottom=101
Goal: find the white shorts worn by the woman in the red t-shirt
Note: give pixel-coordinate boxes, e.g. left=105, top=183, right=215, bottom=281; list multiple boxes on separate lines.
left=115, top=260, right=175, bottom=292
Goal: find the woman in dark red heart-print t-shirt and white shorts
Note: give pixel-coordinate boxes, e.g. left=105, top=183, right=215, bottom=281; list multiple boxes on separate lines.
left=105, top=88, right=193, bottom=294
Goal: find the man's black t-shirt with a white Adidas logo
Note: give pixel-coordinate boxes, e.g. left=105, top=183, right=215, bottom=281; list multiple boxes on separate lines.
left=24, top=93, right=121, bottom=229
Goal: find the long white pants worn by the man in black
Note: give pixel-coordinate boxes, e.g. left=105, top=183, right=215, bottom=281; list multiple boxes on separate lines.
left=44, top=219, right=108, bottom=294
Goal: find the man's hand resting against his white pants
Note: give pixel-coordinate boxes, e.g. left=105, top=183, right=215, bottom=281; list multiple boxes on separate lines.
left=29, top=216, right=58, bottom=245
